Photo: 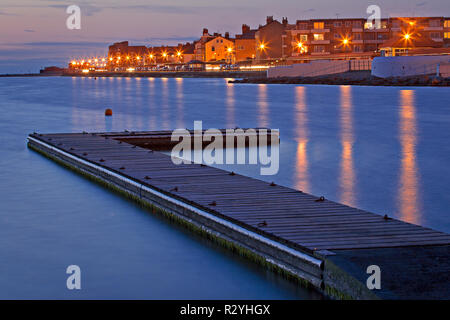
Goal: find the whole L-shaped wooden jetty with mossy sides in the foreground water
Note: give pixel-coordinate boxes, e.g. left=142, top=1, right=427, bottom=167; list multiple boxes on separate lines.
left=28, top=130, right=450, bottom=299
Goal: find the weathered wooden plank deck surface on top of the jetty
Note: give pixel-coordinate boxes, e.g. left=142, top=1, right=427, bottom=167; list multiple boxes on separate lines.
left=31, top=131, right=450, bottom=251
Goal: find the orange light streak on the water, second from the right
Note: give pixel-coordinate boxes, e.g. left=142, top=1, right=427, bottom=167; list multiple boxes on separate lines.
left=339, top=86, right=356, bottom=206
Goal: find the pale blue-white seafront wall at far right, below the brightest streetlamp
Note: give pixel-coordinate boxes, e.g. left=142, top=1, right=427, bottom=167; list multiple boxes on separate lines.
left=372, top=55, right=450, bottom=78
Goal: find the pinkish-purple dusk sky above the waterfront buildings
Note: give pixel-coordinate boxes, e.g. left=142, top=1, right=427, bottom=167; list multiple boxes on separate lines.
left=0, top=0, right=450, bottom=73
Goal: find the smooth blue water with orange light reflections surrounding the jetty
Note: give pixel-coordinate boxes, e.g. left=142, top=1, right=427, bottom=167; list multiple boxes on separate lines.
left=0, top=78, right=450, bottom=299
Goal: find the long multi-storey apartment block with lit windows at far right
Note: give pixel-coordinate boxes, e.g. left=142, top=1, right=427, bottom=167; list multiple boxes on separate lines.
left=283, top=17, right=450, bottom=62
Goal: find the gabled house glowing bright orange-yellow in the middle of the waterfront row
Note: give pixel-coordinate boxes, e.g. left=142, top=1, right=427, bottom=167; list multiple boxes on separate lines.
left=205, top=33, right=236, bottom=63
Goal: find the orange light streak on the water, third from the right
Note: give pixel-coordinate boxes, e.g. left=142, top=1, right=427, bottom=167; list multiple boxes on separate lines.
left=294, top=87, right=310, bottom=192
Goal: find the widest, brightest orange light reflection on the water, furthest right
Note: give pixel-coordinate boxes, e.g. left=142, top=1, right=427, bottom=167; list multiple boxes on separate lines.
left=398, top=90, right=420, bottom=224
